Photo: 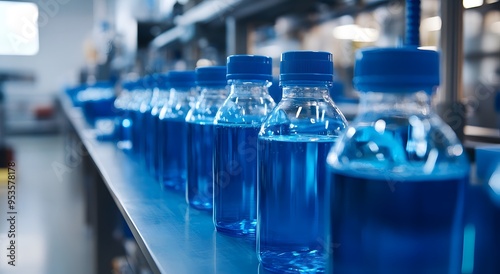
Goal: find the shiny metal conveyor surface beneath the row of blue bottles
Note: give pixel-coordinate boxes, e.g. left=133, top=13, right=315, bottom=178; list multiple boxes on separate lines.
left=61, top=97, right=263, bottom=274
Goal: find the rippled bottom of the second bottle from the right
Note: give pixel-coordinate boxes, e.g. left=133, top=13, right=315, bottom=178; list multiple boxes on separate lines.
left=259, top=250, right=326, bottom=273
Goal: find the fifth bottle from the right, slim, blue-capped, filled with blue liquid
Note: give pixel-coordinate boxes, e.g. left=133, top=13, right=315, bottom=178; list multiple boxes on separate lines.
left=158, top=71, right=196, bottom=191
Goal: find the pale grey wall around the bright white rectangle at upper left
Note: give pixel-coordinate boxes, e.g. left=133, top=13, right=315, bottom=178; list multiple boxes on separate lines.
left=0, top=0, right=93, bottom=94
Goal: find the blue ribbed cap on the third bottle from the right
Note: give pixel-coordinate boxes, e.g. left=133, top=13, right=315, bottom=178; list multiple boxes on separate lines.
left=226, top=55, right=273, bottom=81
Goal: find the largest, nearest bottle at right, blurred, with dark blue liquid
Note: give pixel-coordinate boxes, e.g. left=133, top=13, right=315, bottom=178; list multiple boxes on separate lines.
left=328, top=47, right=469, bottom=273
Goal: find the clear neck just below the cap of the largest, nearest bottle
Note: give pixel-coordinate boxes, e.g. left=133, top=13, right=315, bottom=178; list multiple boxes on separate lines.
left=359, top=91, right=431, bottom=115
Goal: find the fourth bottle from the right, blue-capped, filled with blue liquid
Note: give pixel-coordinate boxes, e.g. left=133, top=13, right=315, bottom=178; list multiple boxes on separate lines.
left=186, top=66, right=228, bottom=210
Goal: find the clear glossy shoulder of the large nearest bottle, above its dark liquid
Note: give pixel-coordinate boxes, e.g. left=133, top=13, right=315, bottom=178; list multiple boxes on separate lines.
left=328, top=113, right=469, bottom=177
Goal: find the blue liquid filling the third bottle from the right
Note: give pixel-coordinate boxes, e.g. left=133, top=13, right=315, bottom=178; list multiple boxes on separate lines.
left=214, top=125, right=260, bottom=234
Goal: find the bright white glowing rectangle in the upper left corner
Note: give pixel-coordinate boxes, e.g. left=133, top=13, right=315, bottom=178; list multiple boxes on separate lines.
left=0, top=1, right=39, bottom=55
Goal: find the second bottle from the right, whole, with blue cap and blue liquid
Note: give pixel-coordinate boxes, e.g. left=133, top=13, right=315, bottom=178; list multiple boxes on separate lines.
left=257, top=51, right=347, bottom=273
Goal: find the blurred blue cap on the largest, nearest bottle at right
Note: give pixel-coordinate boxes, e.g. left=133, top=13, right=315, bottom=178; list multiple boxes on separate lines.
left=353, top=47, right=439, bottom=93
